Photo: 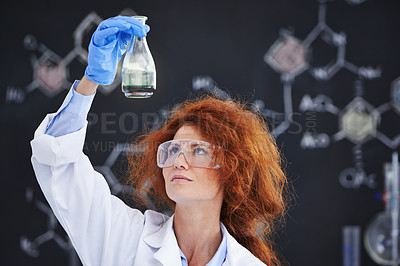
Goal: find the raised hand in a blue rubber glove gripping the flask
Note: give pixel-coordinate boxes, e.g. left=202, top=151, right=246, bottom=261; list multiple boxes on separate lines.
left=85, top=16, right=150, bottom=85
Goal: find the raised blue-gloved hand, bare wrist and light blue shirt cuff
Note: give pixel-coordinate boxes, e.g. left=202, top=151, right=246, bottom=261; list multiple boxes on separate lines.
left=46, top=16, right=149, bottom=137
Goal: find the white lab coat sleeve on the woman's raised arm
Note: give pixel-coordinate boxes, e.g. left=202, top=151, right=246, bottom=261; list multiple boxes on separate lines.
left=31, top=114, right=144, bottom=266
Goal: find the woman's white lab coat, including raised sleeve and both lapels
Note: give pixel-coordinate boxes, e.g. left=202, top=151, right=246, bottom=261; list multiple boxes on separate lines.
left=31, top=114, right=265, bottom=266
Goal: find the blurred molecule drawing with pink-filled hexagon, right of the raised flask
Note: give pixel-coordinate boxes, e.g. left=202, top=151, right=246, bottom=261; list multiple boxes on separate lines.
left=260, top=0, right=380, bottom=137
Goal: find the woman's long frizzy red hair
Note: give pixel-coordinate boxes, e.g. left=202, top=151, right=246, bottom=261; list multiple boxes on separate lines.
left=128, top=95, right=287, bottom=265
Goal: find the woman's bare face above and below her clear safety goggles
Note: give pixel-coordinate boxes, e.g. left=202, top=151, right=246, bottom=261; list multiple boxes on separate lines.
left=162, top=125, right=223, bottom=208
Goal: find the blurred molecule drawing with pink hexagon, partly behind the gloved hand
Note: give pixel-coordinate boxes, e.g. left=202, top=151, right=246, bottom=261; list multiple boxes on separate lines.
left=5, top=9, right=136, bottom=104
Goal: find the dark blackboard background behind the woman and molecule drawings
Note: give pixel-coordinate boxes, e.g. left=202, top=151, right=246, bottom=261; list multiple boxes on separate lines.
left=0, top=0, right=400, bottom=265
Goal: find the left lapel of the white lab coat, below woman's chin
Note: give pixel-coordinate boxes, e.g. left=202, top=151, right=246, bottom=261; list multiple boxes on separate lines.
left=143, top=216, right=182, bottom=266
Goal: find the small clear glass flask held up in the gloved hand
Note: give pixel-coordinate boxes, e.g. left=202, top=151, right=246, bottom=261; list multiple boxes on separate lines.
left=122, top=16, right=156, bottom=98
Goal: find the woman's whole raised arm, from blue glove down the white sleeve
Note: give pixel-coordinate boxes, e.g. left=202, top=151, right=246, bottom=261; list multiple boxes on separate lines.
left=31, top=16, right=148, bottom=265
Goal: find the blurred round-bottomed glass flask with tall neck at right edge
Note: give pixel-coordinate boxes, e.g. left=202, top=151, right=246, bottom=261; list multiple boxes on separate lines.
left=364, top=153, right=400, bottom=265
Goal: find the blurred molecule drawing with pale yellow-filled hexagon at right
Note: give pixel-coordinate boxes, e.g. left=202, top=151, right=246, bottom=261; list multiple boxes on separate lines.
left=300, top=75, right=400, bottom=188
